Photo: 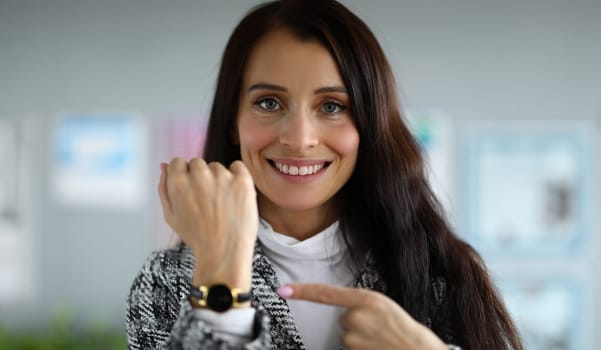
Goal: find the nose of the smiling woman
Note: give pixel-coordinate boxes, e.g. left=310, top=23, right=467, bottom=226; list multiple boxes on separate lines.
left=280, top=109, right=319, bottom=151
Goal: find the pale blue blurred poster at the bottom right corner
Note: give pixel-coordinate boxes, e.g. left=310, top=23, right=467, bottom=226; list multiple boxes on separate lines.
left=499, top=275, right=592, bottom=350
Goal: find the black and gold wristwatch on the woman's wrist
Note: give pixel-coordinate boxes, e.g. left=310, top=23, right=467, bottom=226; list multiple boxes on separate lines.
left=190, top=284, right=250, bottom=312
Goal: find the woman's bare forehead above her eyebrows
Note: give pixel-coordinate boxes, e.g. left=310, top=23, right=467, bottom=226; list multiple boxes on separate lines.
left=239, top=29, right=342, bottom=85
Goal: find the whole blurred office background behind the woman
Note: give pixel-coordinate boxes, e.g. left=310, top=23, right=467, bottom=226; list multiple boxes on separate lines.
left=0, top=0, right=601, bottom=349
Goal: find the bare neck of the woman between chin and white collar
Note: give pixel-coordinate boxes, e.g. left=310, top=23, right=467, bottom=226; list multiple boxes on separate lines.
left=258, top=195, right=336, bottom=241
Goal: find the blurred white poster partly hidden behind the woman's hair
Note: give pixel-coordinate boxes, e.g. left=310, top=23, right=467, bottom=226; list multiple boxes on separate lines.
left=407, top=108, right=455, bottom=219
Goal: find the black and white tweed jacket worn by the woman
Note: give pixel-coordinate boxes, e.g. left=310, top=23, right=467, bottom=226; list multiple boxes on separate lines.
left=126, top=243, right=456, bottom=350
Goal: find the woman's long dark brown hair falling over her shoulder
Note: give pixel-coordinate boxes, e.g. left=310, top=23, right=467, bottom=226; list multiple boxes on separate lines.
left=204, top=0, right=522, bottom=349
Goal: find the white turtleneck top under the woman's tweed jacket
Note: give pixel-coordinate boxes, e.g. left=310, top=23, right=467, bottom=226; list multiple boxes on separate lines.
left=196, top=219, right=354, bottom=350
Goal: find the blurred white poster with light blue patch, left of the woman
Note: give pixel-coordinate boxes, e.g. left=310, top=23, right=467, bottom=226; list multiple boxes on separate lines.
left=51, top=112, right=148, bottom=210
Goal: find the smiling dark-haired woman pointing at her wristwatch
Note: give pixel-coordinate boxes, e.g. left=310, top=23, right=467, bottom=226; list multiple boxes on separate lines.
left=127, top=0, right=521, bottom=349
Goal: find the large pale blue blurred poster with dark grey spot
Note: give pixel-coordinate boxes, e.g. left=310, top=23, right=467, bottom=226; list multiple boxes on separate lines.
left=461, top=122, right=593, bottom=257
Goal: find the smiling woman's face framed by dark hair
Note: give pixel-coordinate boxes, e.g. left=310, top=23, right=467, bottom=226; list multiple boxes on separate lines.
left=237, top=30, right=359, bottom=217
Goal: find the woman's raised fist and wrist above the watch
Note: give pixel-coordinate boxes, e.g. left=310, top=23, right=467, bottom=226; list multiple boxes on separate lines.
left=159, top=158, right=259, bottom=290
